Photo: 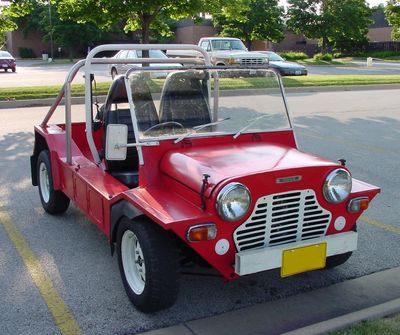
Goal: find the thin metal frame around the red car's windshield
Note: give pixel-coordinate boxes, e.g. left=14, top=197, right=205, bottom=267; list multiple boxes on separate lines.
left=124, top=65, right=293, bottom=144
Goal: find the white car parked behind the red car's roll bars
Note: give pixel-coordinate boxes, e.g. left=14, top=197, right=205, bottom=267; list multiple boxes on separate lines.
left=109, top=50, right=181, bottom=79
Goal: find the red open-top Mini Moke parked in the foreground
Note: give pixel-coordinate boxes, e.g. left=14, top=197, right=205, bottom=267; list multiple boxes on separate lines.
left=31, top=45, right=380, bottom=312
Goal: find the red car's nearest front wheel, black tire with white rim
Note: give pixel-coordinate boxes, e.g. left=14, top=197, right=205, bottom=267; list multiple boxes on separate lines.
left=117, top=218, right=179, bottom=313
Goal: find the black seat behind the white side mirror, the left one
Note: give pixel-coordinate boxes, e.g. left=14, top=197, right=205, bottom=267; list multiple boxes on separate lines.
left=102, top=77, right=159, bottom=188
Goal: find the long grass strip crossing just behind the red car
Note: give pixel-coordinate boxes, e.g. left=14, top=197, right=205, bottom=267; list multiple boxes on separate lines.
left=0, top=75, right=400, bottom=101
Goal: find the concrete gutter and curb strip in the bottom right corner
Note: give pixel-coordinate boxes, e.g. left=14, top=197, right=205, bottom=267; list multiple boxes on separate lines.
left=143, top=267, right=400, bottom=335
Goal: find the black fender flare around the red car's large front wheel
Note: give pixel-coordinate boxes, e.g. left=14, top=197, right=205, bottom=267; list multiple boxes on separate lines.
left=110, top=200, right=145, bottom=255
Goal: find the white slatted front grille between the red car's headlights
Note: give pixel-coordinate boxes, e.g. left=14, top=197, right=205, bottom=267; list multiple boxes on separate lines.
left=233, top=189, right=332, bottom=251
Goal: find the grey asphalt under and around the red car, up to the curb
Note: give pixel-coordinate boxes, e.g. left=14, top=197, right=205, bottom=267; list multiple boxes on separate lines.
left=0, top=90, right=400, bottom=335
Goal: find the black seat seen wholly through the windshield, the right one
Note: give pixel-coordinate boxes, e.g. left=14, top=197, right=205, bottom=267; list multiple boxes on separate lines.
left=160, top=70, right=211, bottom=128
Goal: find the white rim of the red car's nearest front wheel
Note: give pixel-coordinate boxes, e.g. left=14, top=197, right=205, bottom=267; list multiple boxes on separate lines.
left=121, top=230, right=146, bottom=295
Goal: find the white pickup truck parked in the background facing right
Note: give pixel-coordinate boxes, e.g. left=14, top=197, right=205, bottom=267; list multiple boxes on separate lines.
left=167, top=37, right=268, bottom=65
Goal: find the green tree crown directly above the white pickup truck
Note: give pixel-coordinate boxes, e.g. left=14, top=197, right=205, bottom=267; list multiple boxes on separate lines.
left=213, top=0, right=285, bottom=48
